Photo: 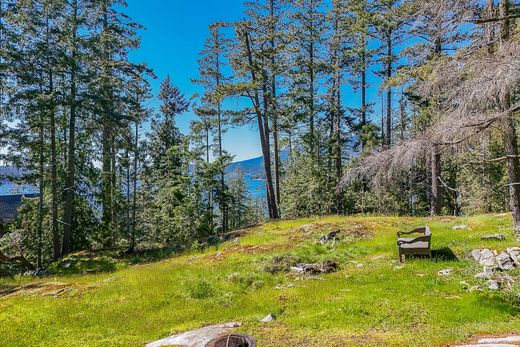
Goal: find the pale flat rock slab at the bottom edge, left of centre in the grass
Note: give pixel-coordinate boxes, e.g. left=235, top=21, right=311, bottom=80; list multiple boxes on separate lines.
left=146, top=322, right=242, bottom=347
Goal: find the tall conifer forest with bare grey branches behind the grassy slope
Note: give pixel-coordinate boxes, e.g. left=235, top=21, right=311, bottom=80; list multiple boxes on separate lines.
left=0, top=0, right=520, bottom=272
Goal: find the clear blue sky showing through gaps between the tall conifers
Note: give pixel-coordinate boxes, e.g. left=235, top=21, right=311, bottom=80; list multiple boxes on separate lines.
left=125, top=0, right=386, bottom=161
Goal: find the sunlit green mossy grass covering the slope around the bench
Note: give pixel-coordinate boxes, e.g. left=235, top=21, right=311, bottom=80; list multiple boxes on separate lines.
left=0, top=216, right=520, bottom=346
